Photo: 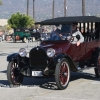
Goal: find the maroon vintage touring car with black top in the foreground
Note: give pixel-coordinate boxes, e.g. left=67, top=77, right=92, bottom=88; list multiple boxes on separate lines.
left=7, top=16, right=100, bottom=90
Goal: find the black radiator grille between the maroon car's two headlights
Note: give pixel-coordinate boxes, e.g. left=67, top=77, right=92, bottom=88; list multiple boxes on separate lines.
left=29, top=47, right=47, bottom=69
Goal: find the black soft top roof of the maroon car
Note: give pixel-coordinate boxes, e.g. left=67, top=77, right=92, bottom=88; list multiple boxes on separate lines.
left=35, top=16, right=100, bottom=25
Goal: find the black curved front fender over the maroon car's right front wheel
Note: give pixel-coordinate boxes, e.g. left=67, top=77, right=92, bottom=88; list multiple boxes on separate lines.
left=53, top=54, right=78, bottom=72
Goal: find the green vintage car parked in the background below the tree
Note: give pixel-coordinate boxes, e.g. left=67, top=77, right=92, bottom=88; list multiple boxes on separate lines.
left=13, top=28, right=30, bottom=42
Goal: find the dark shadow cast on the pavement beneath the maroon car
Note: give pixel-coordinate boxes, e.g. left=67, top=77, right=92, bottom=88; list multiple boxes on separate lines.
left=0, top=70, right=100, bottom=90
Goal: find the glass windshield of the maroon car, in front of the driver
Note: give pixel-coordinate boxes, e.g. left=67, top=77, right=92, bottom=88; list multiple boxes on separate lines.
left=41, top=24, right=71, bottom=41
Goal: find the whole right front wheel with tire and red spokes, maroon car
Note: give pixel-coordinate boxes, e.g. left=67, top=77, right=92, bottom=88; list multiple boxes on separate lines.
left=55, top=58, right=70, bottom=90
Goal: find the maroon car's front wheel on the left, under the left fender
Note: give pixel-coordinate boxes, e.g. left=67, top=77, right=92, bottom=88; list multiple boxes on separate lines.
left=7, top=61, right=23, bottom=85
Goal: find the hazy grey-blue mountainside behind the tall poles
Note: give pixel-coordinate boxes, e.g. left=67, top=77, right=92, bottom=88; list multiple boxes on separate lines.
left=0, top=0, right=100, bottom=21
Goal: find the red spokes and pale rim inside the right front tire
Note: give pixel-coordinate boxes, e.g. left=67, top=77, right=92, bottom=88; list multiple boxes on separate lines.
left=60, top=62, right=69, bottom=86
